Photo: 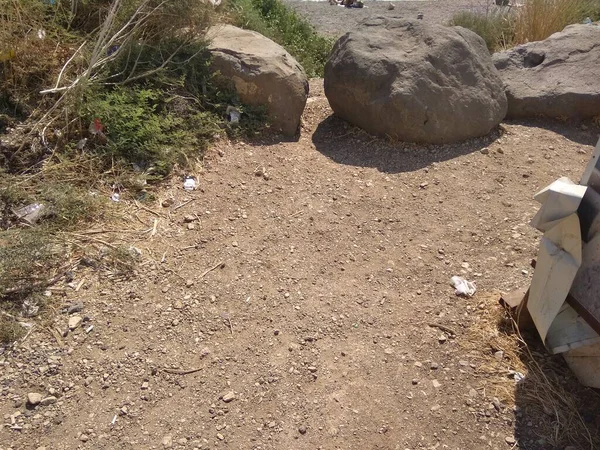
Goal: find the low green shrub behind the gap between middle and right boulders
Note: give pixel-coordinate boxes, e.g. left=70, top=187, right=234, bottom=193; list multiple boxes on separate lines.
left=450, top=11, right=515, bottom=53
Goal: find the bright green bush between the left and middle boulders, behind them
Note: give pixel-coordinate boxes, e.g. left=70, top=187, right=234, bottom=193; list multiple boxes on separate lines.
left=230, top=0, right=333, bottom=77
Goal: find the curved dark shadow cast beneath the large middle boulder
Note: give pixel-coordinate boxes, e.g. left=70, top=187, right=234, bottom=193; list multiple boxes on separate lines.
left=312, top=115, right=502, bottom=173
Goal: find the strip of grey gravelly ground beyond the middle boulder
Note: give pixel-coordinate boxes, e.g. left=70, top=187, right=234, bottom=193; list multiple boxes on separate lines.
left=286, top=0, right=488, bottom=38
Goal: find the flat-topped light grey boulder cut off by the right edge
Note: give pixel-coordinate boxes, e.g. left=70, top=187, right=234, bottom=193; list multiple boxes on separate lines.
left=493, top=25, right=600, bottom=118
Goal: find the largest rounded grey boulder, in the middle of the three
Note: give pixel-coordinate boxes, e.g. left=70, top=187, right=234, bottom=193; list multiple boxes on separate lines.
left=325, top=17, right=507, bottom=144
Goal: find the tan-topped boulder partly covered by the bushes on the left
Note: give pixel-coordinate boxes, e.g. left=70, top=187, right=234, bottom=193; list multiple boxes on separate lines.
left=207, top=25, right=308, bottom=136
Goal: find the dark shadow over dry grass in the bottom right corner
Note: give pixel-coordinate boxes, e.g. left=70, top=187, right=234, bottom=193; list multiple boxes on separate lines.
left=514, top=326, right=600, bottom=450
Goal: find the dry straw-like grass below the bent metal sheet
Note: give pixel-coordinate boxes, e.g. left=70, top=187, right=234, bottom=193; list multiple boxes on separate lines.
left=464, top=294, right=600, bottom=450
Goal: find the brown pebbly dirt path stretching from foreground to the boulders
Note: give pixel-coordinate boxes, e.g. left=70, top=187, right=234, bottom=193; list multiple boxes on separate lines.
left=0, top=80, right=598, bottom=450
